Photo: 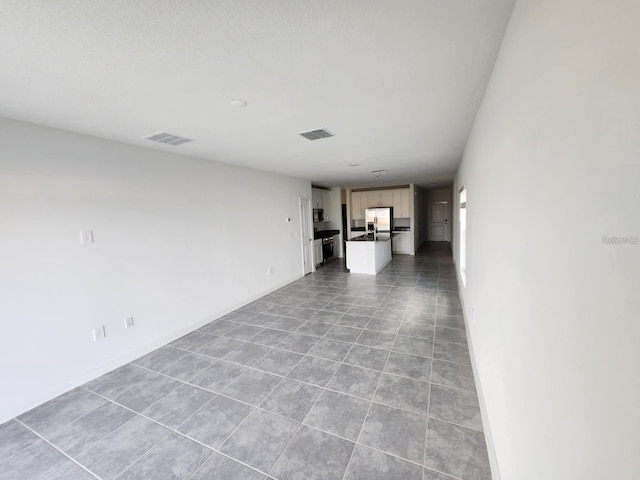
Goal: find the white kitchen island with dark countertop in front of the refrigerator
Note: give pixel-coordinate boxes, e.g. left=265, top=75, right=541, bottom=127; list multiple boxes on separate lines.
left=347, top=233, right=393, bottom=275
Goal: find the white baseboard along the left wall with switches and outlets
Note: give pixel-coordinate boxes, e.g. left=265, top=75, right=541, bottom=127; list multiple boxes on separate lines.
left=0, top=274, right=303, bottom=424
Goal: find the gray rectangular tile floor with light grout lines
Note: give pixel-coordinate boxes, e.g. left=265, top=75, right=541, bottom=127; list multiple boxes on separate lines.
left=0, top=245, right=491, bottom=480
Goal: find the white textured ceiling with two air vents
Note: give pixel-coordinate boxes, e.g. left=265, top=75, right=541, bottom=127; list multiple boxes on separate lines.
left=0, top=0, right=513, bottom=187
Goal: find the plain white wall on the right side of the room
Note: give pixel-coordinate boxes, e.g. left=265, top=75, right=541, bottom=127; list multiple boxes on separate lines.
left=454, top=0, right=640, bottom=480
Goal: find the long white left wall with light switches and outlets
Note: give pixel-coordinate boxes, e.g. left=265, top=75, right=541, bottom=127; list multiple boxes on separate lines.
left=0, top=119, right=311, bottom=422
